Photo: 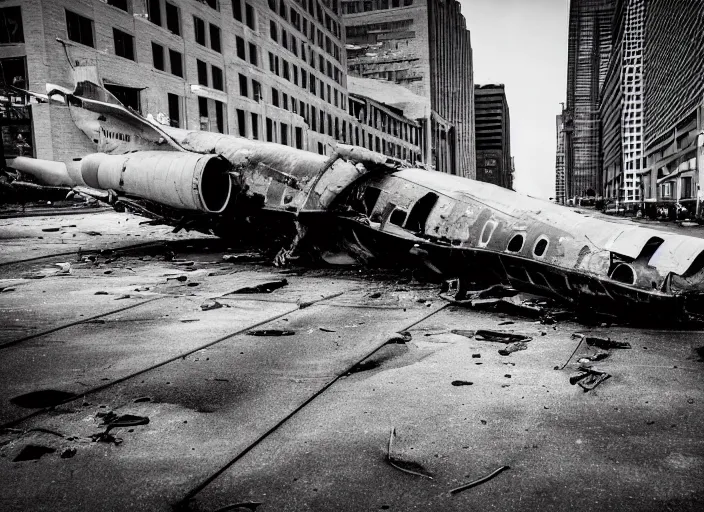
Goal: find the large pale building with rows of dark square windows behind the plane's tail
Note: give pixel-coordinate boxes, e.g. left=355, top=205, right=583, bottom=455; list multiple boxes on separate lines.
left=0, top=0, right=360, bottom=160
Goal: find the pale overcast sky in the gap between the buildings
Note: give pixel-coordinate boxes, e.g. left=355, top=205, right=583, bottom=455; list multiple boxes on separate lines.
left=460, top=0, right=569, bottom=199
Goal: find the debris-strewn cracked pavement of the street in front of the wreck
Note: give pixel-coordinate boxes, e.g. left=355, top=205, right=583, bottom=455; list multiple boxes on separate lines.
left=0, top=212, right=704, bottom=512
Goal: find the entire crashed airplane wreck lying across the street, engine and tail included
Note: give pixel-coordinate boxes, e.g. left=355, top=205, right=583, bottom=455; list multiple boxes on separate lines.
left=7, top=81, right=704, bottom=320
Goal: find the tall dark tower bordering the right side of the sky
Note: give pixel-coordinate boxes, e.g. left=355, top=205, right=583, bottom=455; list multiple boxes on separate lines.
left=563, top=0, right=615, bottom=198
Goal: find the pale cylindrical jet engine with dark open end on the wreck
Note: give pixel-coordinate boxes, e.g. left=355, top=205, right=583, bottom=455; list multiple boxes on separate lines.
left=81, top=151, right=232, bottom=213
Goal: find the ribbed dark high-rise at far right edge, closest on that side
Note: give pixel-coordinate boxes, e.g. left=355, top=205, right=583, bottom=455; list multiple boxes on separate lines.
left=641, top=0, right=704, bottom=215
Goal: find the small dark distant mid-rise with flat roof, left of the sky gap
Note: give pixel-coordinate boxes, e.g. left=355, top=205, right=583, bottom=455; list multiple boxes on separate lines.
left=474, top=84, right=513, bottom=189
